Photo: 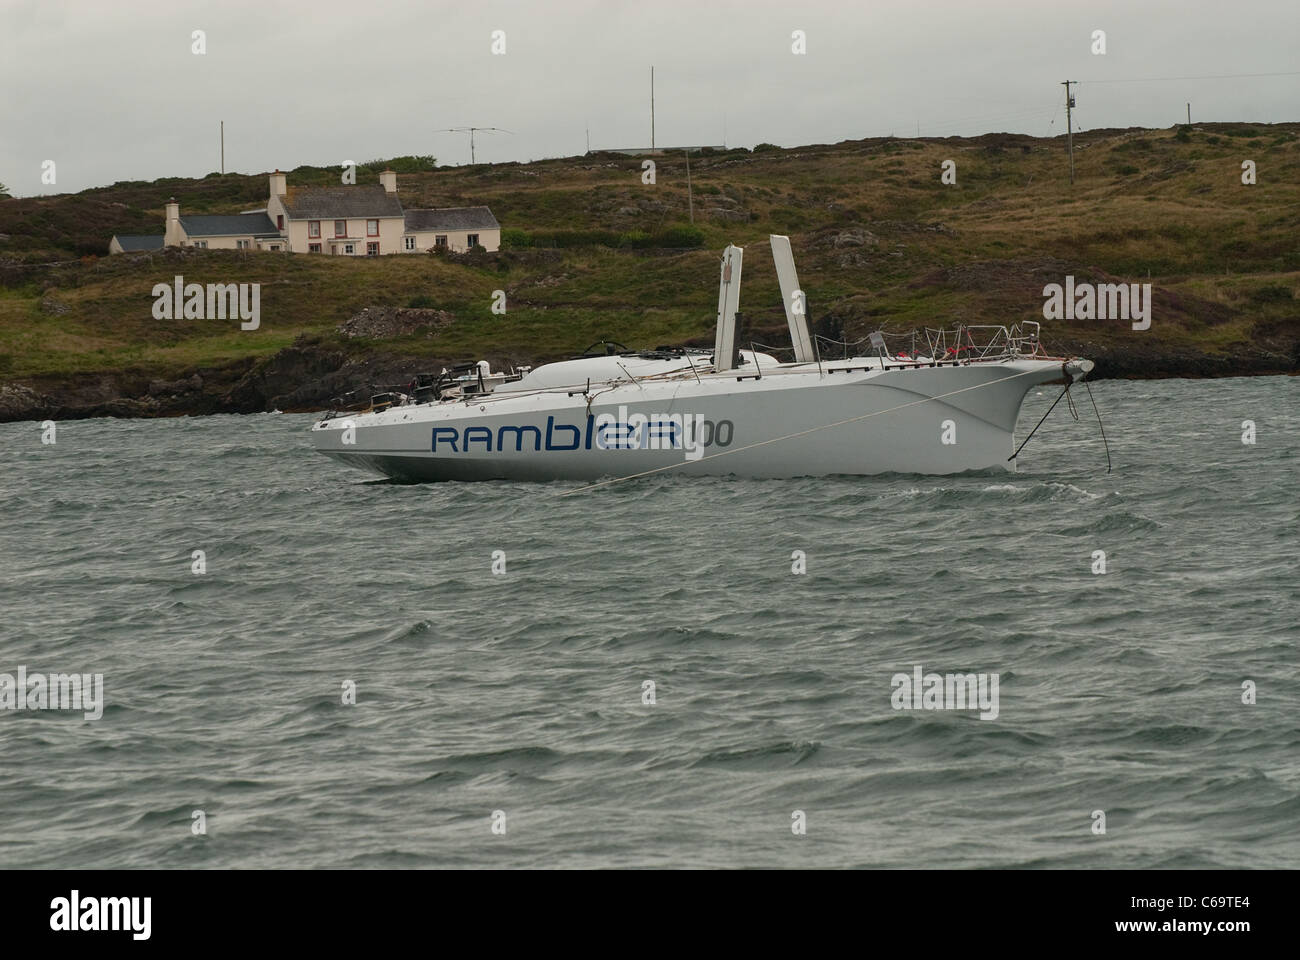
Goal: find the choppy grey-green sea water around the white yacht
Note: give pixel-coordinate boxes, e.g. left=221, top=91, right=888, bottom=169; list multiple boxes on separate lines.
left=0, top=377, right=1300, bottom=868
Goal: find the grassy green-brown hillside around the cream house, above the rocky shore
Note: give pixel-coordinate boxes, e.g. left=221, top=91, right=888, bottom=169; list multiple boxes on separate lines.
left=0, top=124, right=1300, bottom=413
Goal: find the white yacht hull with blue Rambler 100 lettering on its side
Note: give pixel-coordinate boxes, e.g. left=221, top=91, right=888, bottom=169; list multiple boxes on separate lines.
left=312, top=355, right=1071, bottom=481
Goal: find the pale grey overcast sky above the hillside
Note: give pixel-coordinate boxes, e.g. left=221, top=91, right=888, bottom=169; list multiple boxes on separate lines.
left=0, top=0, right=1300, bottom=196
